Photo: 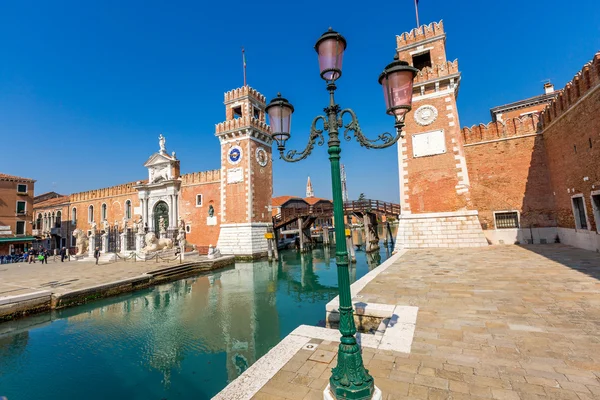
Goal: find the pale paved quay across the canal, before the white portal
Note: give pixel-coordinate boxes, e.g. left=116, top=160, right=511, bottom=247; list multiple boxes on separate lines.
left=0, top=257, right=195, bottom=298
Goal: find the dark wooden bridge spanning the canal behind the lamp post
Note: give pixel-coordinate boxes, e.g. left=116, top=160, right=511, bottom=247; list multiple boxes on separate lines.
left=273, top=199, right=400, bottom=252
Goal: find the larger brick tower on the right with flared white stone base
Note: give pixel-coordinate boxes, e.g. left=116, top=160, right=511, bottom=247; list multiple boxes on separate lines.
left=396, top=21, right=487, bottom=248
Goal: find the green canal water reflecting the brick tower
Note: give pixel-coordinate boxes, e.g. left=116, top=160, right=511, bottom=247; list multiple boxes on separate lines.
left=0, top=248, right=389, bottom=400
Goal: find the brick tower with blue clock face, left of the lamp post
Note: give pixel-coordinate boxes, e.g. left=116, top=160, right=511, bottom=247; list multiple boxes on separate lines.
left=215, top=86, right=273, bottom=258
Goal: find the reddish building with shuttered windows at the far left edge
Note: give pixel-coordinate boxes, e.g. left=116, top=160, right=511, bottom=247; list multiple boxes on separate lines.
left=0, top=173, right=35, bottom=255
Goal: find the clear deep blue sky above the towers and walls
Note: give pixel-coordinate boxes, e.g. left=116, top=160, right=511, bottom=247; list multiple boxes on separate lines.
left=0, top=0, right=600, bottom=202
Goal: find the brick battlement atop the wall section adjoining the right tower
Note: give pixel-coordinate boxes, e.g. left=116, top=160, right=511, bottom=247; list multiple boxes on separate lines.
left=462, top=114, right=540, bottom=145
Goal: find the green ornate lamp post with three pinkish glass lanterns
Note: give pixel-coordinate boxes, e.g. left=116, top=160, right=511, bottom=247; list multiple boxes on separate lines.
left=266, top=28, right=418, bottom=399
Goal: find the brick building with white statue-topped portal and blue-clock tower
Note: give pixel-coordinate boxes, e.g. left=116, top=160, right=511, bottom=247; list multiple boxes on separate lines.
left=33, top=86, right=273, bottom=257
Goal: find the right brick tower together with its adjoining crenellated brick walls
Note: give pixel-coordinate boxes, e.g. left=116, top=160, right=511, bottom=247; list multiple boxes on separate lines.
left=397, top=22, right=600, bottom=251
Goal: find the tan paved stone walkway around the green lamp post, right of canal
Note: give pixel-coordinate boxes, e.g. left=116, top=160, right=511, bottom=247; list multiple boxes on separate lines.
left=246, top=245, right=600, bottom=400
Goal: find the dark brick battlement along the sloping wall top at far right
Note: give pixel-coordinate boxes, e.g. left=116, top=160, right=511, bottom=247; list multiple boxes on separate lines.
left=541, top=51, right=600, bottom=127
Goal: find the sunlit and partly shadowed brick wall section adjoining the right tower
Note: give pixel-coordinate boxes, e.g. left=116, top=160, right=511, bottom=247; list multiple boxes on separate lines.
left=463, top=116, right=555, bottom=229
